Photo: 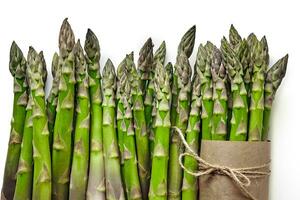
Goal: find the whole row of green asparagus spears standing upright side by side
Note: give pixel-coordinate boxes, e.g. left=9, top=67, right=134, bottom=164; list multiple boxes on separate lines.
left=1, top=19, right=288, bottom=200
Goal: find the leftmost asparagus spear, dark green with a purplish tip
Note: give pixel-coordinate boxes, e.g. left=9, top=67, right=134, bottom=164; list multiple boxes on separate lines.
left=1, top=42, right=28, bottom=200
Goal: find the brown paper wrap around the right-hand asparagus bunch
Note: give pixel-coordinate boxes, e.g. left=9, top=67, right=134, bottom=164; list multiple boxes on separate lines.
left=199, top=140, right=270, bottom=200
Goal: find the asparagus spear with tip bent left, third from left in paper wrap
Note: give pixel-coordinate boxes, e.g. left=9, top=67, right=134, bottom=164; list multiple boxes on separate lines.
left=221, top=38, right=248, bottom=141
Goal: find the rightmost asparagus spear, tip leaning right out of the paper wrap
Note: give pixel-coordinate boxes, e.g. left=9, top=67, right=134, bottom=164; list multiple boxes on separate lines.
left=262, top=55, right=289, bottom=141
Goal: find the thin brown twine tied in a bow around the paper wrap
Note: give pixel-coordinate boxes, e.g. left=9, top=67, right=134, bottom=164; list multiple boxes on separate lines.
left=173, top=127, right=270, bottom=200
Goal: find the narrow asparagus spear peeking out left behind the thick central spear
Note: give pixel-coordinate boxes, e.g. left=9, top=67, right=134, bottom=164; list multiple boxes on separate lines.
left=144, top=41, right=166, bottom=158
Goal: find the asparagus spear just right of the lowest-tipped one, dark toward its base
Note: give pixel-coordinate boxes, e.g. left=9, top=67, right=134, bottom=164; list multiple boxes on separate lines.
left=124, top=53, right=150, bottom=199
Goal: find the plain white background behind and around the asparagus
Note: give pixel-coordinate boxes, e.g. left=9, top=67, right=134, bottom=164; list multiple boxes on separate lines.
left=0, top=0, right=300, bottom=200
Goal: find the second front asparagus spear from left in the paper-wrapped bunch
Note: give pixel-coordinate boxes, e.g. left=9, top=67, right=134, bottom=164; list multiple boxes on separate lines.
left=211, top=47, right=228, bottom=140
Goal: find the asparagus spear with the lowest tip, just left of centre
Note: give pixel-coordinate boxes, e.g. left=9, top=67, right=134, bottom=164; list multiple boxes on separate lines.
left=118, top=55, right=142, bottom=199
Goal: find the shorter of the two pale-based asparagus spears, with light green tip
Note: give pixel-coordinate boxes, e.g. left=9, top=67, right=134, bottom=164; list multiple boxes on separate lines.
left=102, top=59, right=125, bottom=200
